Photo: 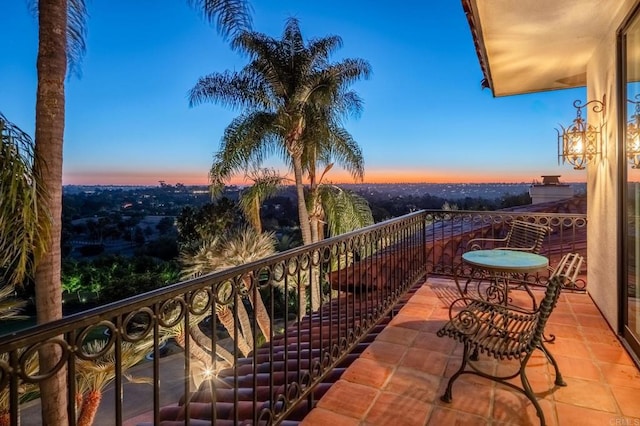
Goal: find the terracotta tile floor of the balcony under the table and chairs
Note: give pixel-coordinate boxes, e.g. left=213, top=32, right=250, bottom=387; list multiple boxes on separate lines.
left=302, top=277, right=640, bottom=426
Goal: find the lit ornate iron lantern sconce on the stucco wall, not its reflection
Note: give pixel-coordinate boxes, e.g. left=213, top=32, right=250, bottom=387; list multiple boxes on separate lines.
left=556, top=95, right=607, bottom=170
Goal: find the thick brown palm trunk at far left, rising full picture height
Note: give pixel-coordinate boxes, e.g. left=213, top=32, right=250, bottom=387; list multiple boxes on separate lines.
left=35, top=0, right=68, bottom=426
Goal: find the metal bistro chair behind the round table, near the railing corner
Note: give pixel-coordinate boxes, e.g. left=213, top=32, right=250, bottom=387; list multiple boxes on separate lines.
left=462, top=219, right=551, bottom=296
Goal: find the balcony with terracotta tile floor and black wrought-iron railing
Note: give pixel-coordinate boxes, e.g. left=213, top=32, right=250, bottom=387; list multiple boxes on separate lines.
left=0, top=199, right=640, bottom=425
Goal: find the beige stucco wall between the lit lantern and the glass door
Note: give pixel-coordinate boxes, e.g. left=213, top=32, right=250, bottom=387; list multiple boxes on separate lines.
left=587, top=0, right=635, bottom=330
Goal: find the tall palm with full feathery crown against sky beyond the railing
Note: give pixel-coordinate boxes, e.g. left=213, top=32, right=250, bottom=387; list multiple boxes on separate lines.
left=189, top=18, right=371, bottom=244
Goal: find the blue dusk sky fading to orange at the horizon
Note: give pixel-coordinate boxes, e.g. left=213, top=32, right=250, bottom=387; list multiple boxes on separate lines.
left=0, top=0, right=586, bottom=185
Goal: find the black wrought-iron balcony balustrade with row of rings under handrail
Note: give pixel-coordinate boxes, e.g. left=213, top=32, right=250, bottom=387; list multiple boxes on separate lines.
left=0, top=210, right=586, bottom=426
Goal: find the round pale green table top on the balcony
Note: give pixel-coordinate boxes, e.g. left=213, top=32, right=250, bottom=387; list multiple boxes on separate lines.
left=462, top=250, right=549, bottom=273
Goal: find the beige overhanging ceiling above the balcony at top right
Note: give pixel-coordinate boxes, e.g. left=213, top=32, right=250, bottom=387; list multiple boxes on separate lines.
left=463, top=0, right=623, bottom=96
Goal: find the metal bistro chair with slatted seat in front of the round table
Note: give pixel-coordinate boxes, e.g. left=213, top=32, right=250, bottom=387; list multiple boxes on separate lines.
left=437, top=275, right=566, bottom=425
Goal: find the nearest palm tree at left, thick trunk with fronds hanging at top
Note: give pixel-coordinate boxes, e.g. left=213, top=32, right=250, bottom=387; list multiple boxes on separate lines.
left=35, top=0, right=250, bottom=425
